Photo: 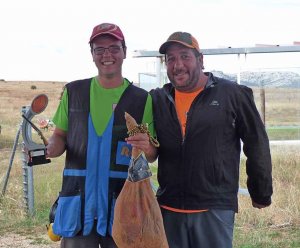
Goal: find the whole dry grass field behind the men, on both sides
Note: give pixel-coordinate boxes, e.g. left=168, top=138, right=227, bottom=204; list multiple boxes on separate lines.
left=0, top=82, right=300, bottom=248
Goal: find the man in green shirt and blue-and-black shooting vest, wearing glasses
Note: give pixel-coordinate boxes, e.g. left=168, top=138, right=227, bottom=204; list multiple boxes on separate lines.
left=47, top=23, right=153, bottom=248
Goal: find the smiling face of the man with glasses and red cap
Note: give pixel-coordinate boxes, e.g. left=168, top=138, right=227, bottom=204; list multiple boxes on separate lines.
left=91, top=35, right=126, bottom=79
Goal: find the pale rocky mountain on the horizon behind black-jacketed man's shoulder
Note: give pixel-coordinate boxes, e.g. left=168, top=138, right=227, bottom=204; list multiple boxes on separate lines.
left=212, top=71, right=300, bottom=88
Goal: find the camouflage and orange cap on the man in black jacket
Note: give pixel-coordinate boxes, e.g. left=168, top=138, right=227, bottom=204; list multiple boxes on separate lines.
left=159, top=32, right=201, bottom=54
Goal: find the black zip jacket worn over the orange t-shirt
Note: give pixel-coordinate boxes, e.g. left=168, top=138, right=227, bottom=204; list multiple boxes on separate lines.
left=150, top=73, right=273, bottom=212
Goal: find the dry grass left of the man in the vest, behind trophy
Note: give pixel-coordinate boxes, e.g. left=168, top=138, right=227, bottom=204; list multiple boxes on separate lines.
left=0, top=81, right=64, bottom=243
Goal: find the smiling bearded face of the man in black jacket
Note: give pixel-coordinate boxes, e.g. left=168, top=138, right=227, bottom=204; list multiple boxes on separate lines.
left=166, top=43, right=203, bottom=92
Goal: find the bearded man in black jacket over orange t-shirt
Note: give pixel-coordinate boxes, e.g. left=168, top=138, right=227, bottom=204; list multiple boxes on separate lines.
left=128, top=32, right=272, bottom=248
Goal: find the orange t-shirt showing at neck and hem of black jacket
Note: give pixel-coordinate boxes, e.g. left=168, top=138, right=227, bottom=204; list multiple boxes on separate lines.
left=161, top=88, right=208, bottom=213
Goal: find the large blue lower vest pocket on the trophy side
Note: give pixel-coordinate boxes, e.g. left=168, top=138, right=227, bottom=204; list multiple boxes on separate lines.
left=53, top=194, right=81, bottom=238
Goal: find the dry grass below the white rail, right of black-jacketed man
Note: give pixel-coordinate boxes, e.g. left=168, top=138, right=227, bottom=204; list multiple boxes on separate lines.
left=234, top=145, right=300, bottom=248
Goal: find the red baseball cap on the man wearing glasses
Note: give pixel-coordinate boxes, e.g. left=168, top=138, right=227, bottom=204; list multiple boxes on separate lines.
left=89, top=23, right=125, bottom=43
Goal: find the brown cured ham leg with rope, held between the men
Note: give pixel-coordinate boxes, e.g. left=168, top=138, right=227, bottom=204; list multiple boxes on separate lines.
left=112, top=113, right=169, bottom=248
